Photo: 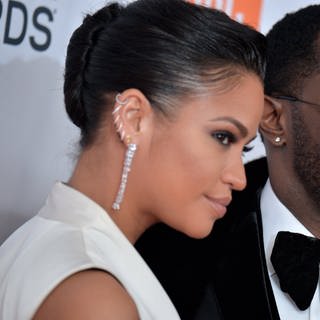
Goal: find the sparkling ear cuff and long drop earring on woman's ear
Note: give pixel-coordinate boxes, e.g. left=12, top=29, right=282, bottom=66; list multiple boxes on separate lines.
left=112, top=93, right=137, bottom=211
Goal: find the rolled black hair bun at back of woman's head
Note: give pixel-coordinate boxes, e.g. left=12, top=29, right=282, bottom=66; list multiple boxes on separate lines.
left=64, top=3, right=122, bottom=130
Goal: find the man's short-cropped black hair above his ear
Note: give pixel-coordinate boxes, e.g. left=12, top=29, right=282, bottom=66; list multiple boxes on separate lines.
left=265, top=5, right=320, bottom=95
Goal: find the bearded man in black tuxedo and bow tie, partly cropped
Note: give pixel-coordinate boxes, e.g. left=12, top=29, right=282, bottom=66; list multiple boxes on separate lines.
left=137, top=5, right=320, bottom=320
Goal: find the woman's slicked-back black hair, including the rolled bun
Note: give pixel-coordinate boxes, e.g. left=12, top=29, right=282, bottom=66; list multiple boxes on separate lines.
left=64, top=0, right=265, bottom=146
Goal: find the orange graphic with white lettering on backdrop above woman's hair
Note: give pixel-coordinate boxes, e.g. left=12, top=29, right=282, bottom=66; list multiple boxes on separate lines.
left=189, top=0, right=263, bottom=29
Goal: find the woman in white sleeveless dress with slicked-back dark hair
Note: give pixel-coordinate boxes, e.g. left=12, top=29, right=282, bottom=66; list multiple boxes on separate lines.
left=0, top=0, right=265, bottom=320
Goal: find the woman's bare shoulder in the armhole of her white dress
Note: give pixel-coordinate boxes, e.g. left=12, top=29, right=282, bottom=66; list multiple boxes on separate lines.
left=33, top=270, right=139, bottom=320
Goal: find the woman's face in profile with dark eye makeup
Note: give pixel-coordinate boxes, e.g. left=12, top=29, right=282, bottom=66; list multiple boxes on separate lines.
left=134, top=74, right=264, bottom=238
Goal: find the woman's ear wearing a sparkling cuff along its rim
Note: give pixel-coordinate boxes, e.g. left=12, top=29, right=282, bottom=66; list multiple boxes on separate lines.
left=112, top=89, right=152, bottom=145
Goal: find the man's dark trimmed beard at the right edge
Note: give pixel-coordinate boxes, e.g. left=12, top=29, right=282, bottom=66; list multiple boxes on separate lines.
left=292, top=106, right=320, bottom=208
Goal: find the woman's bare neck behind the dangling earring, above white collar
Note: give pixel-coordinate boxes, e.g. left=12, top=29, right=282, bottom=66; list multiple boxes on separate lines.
left=68, top=146, right=156, bottom=244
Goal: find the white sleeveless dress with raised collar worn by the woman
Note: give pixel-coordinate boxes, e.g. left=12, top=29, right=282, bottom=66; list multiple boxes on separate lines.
left=0, top=182, right=180, bottom=320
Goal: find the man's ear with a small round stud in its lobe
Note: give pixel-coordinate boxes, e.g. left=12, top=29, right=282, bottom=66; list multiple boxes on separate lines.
left=259, top=96, right=286, bottom=146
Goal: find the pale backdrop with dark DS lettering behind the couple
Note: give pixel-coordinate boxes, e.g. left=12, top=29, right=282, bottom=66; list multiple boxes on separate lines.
left=0, top=0, right=319, bottom=243
